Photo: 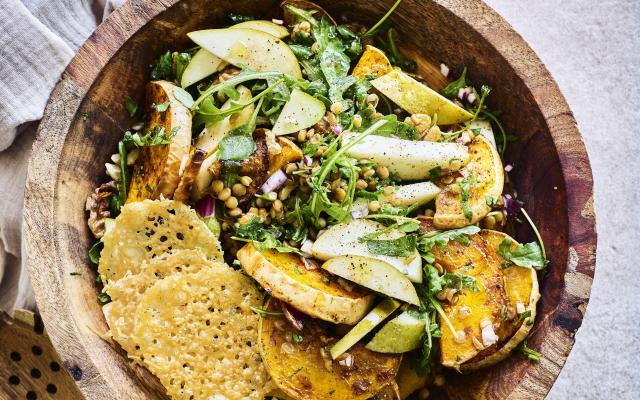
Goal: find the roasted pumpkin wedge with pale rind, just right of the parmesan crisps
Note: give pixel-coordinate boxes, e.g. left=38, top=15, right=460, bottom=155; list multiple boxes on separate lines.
left=237, top=243, right=374, bottom=325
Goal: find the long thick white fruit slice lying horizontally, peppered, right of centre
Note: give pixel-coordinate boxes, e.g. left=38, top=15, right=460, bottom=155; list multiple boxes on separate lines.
left=342, top=132, right=469, bottom=181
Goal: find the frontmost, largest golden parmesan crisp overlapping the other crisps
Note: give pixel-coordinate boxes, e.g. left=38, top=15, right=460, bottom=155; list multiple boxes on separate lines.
left=133, top=268, right=272, bottom=400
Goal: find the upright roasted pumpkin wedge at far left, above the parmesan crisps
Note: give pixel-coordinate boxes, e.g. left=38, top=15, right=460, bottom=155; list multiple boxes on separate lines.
left=127, top=81, right=191, bottom=203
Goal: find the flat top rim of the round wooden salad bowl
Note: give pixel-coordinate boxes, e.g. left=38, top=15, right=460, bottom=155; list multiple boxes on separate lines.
left=24, top=0, right=596, bottom=399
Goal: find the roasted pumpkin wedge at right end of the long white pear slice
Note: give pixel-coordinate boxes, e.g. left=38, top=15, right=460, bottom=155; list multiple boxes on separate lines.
left=433, top=135, right=504, bottom=229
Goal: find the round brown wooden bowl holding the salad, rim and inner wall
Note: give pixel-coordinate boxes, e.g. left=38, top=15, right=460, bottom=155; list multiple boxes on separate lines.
left=25, top=0, right=596, bottom=400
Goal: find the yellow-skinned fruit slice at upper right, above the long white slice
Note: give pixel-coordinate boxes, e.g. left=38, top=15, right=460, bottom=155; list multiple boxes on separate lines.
left=371, top=69, right=473, bottom=125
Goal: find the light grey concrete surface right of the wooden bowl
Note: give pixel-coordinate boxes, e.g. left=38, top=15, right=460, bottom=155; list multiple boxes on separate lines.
left=486, top=0, right=640, bottom=400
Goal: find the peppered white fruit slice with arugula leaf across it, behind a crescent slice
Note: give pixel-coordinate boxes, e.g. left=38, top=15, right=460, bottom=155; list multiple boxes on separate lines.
left=311, top=219, right=422, bottom=283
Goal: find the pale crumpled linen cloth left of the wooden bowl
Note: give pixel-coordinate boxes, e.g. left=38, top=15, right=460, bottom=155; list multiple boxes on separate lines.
left=0, top=0, right=124, bottom=312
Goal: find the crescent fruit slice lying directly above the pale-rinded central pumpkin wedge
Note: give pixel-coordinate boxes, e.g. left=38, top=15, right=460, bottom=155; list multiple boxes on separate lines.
left=322, top=256, right=420, bottom=306
